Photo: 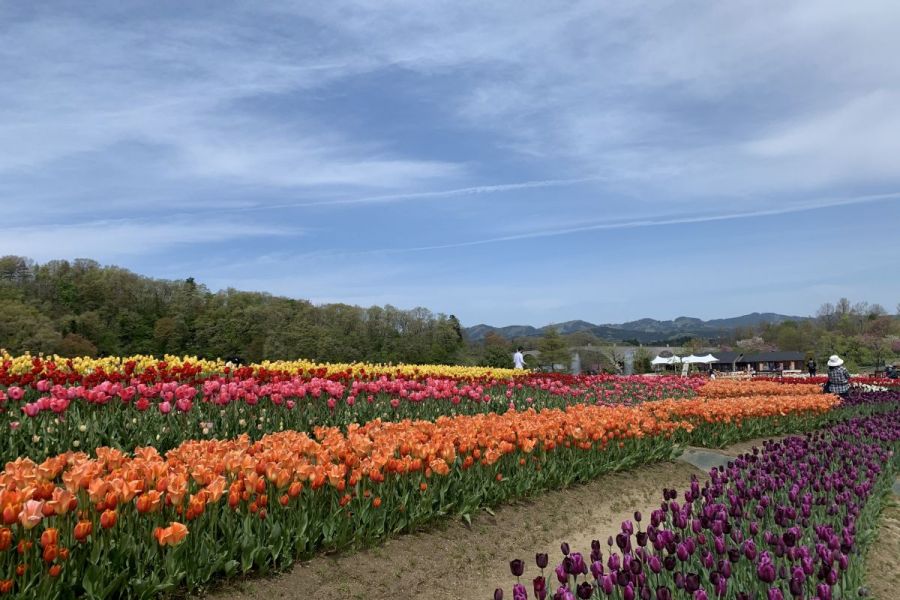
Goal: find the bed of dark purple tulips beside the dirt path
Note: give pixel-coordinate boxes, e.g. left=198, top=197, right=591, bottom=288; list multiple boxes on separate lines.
left=494, top=410, right=900, bottom=600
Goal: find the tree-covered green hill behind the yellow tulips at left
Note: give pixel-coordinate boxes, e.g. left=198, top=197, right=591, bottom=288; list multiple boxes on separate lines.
left=0, top=256, right=463, bottom=363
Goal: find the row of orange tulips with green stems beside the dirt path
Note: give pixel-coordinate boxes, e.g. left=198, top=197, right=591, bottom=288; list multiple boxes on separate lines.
left=0, top=394, right=837, bottom=598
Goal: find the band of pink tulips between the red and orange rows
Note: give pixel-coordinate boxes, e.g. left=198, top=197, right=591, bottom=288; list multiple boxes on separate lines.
left=0, top=375, right=701, bottom=461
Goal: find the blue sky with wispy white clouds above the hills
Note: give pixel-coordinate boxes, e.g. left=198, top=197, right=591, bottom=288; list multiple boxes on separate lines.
left=0, top=0, right=900, bottom=325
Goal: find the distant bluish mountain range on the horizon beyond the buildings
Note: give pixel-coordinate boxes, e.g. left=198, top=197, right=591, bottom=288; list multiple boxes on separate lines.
left=465, top=313, right=809, bottom=344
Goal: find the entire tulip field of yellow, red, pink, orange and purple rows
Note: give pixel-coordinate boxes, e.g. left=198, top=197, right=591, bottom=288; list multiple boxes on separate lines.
left=0, top=354, right=900, bottom=600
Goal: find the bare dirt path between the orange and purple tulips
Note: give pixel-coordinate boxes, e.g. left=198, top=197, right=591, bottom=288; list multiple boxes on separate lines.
left=210, top=462, right=703, bottom=600
